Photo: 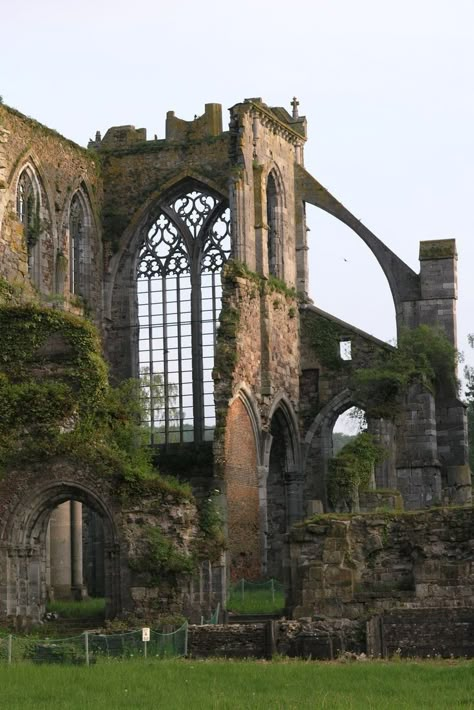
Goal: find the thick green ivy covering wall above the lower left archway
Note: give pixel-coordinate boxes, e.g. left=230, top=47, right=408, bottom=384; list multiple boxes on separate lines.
left=0, top=304, right=192, bottom=500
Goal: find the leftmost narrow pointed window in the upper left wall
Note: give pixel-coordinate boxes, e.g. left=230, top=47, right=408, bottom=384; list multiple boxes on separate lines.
left=16, top=165, right=41, bottom=286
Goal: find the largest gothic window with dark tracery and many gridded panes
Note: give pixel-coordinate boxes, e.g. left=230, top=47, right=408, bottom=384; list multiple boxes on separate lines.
left=137, top=188, right=230, bottom=444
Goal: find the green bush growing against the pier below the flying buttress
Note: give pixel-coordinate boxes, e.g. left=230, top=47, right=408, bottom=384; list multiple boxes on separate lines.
left=352, top=325, right=457, bottom=418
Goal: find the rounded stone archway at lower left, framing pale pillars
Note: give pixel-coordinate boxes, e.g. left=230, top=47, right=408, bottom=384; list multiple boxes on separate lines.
left=0, top=470, right=123, bottom=625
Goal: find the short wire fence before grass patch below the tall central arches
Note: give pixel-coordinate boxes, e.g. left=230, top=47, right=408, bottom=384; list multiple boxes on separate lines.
left=227, top=579, right=285, bottom=614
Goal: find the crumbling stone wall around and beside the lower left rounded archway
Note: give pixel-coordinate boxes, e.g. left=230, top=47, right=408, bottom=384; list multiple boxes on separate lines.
left=0, top=458, right=221, bottom=623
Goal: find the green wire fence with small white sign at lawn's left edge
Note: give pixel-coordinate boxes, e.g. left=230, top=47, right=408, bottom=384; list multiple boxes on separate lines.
left=0, top=622, right=188, bottom=666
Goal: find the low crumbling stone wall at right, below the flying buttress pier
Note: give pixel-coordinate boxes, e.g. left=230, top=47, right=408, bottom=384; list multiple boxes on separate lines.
left=288, top=508, right=474, bottom=619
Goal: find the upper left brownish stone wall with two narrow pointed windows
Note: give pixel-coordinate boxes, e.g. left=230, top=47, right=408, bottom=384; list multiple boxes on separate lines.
left=0, top=105, right=102, bottom=322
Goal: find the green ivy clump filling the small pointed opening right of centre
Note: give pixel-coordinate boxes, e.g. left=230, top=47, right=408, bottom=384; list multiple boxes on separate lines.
left=328, top=432, right=385, bottom=509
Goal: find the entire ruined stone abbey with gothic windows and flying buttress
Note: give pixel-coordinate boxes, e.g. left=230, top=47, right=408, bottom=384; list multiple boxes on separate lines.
left=0, top=98, right=474, bottom=648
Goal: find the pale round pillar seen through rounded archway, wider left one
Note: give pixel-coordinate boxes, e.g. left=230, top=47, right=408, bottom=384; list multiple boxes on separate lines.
left=49, top=501, right=71, bottom=599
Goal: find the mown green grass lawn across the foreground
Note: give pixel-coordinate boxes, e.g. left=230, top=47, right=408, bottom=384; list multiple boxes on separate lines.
left=0, top=659, right=474, bottom=710
